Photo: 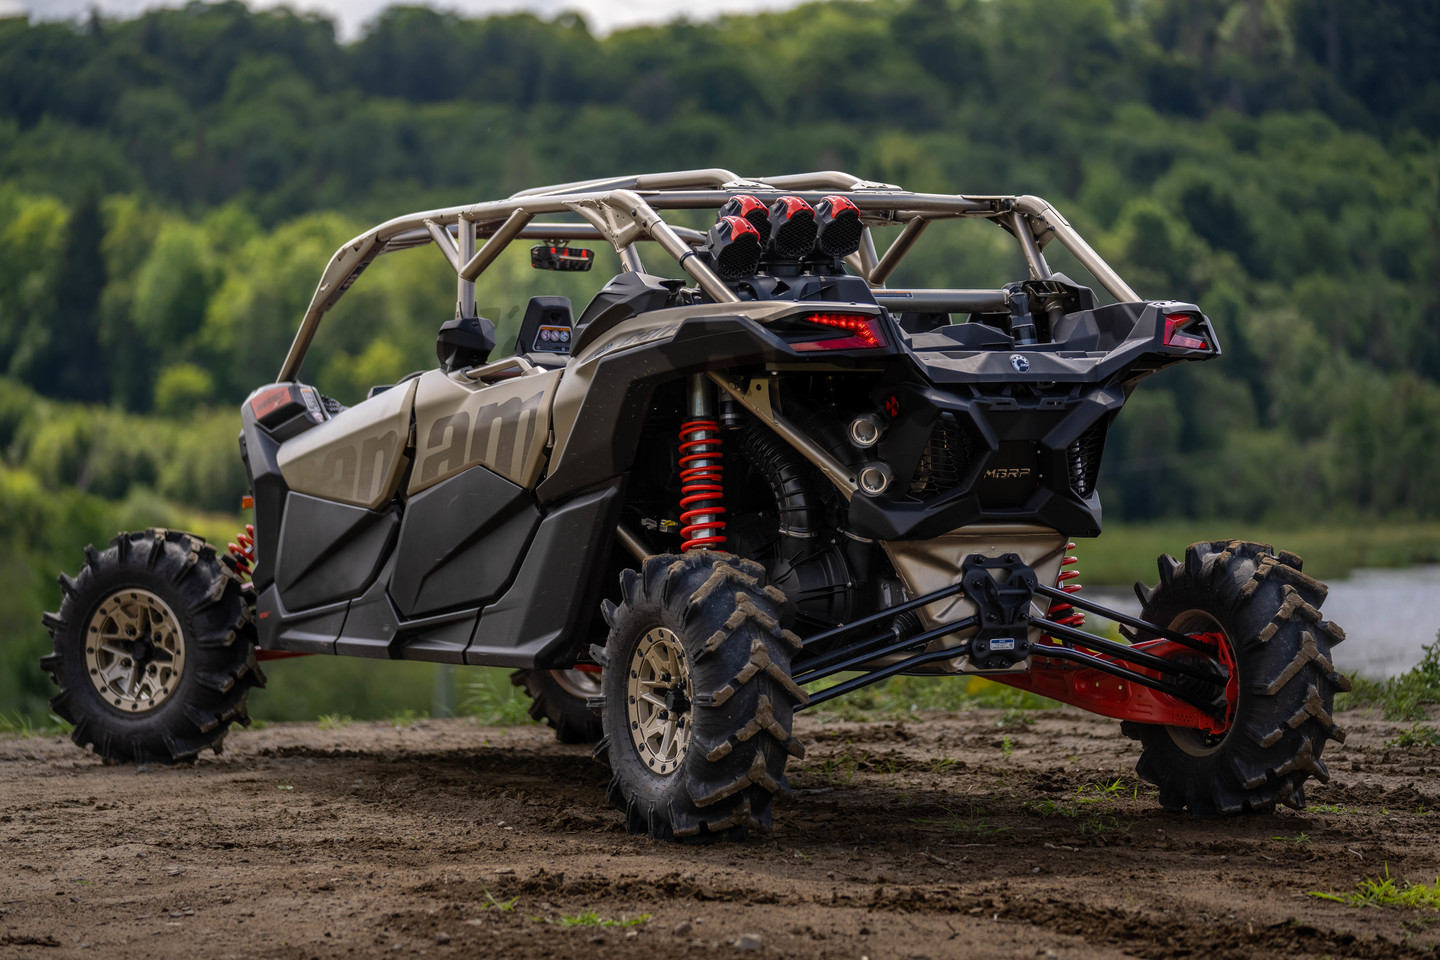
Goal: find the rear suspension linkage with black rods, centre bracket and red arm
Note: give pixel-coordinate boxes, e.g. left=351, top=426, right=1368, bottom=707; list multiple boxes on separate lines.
left=795, top=554, right=1238, bottom=734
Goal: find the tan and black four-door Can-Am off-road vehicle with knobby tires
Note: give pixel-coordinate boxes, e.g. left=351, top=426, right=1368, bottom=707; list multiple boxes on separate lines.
left=43, top=170, right=1345, bottom=841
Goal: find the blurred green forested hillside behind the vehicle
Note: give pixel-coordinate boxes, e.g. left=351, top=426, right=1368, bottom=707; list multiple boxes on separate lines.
left=0, top=0, right=1440, bottom=720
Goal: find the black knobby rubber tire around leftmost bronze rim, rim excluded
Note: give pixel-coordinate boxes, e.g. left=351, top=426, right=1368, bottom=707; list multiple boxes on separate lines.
left=40, top=530, right=265, bottom=763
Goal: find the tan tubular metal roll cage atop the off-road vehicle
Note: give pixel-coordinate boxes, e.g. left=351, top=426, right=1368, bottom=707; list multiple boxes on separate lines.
left=278, top=168, right=1140, bottom=381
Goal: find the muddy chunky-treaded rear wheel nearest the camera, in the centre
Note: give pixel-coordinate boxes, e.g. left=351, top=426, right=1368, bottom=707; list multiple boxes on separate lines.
left=592, top=551, right=806, bottom=842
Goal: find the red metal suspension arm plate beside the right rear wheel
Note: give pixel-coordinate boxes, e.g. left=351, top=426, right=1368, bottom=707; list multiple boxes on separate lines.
left=986, top=633, right=1240, bottom=734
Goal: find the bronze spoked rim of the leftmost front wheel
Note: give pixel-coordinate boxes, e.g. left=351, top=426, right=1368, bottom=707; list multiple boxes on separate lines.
left=85, top=589, right=184, bottom=714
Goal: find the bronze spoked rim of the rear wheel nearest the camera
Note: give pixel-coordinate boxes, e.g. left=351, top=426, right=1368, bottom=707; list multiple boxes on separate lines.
left=625, top=626, right=694, bottom=776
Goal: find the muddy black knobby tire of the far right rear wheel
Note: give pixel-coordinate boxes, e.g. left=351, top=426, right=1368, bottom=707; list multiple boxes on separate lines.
left=1122, top=540, right=1349, bottom=818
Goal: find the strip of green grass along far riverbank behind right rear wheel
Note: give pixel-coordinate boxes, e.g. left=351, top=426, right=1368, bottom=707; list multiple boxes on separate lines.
left=1076, top=520, right=1440, bottom=587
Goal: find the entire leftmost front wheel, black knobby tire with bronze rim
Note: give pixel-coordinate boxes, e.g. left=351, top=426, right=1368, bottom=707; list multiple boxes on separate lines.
left=40, top=530, right=265, bottom=763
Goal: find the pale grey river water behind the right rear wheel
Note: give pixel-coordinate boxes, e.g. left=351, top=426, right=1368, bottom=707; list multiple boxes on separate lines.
left=1083, top=566, right=1440, bottom=679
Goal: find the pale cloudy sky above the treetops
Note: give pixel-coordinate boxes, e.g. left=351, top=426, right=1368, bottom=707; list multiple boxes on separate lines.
left=0, top=0, right=801, bottom=40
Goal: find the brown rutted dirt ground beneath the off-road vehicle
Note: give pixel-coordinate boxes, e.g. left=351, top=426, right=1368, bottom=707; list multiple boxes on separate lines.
left=0, top=708, right=1440, bottom=960
